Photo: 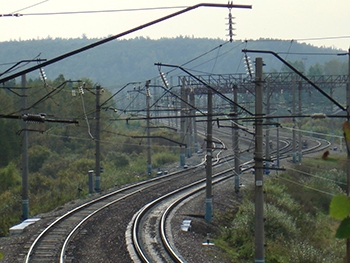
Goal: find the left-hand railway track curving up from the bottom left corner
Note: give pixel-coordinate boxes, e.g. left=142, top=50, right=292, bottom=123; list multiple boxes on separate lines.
left=24, top=170, right=204, bottom=263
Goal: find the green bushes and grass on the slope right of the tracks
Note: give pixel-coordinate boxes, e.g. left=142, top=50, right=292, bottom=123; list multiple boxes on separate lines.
left=215, top=156, right=346, bottom=263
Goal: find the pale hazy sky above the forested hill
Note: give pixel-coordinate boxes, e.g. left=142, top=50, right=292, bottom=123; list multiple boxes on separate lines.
left=0, top=0, right=350, bottom=51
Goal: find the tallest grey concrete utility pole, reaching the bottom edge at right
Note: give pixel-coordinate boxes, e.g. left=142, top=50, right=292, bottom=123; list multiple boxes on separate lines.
left=254, top=58, right=265, bottom=263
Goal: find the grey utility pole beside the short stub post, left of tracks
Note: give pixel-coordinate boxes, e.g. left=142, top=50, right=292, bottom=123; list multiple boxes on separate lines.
left=95, top=85, right=101, bottom=193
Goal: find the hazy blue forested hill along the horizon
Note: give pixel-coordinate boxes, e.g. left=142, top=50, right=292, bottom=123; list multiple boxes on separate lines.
left=0, top=37, right=347, bottom=87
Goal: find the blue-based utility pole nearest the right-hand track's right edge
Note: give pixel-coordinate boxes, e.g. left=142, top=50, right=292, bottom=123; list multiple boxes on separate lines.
left=205, top=89, right=213, bottom=222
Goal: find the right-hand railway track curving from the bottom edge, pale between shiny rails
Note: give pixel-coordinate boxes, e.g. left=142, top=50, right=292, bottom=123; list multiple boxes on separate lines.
left=127, top=170, right=232, bottom=263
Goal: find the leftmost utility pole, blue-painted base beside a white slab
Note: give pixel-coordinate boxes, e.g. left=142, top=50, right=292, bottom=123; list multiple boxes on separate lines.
left=21, top=74, right=29, bottom=220
